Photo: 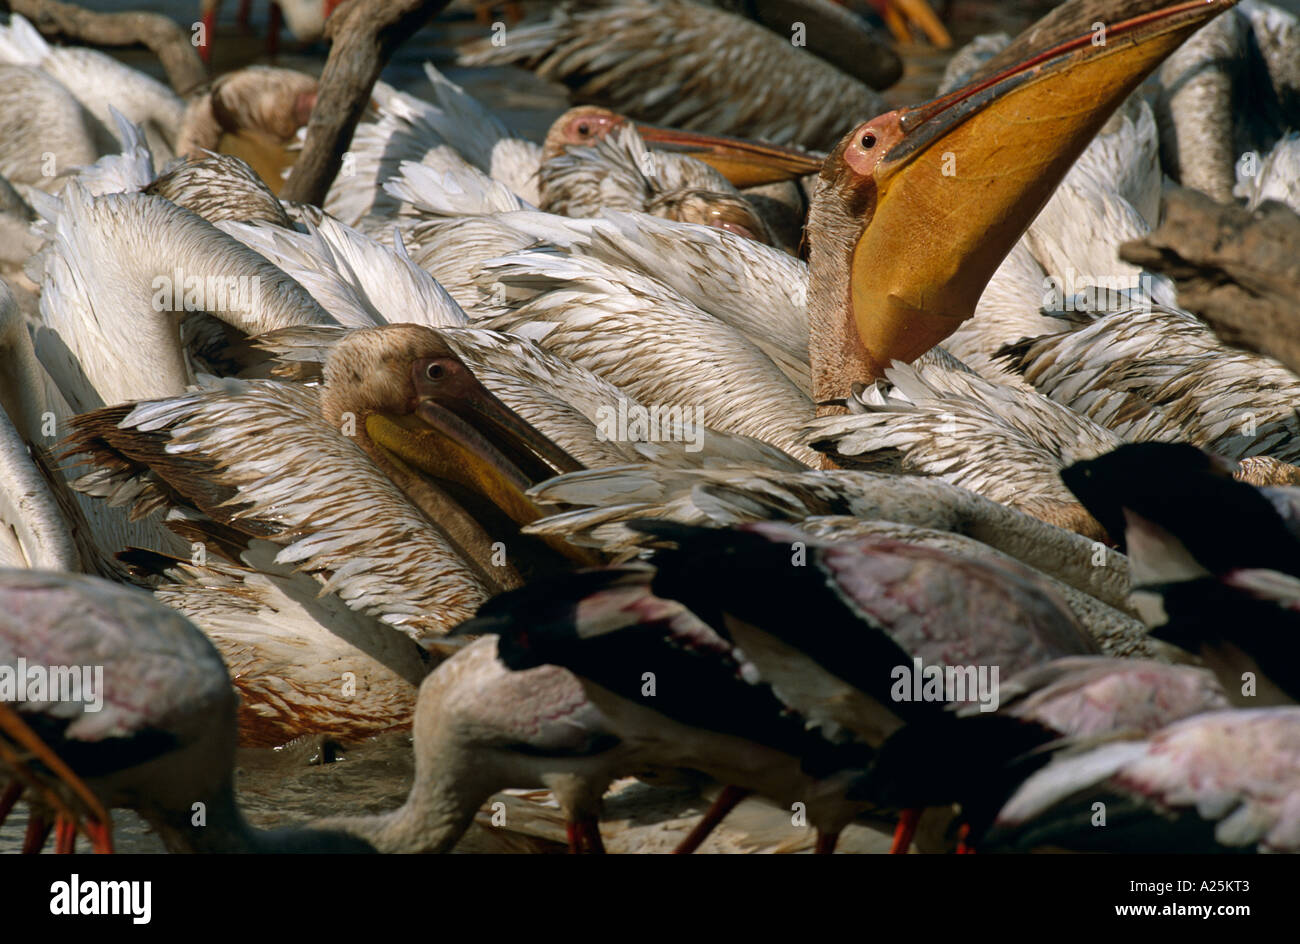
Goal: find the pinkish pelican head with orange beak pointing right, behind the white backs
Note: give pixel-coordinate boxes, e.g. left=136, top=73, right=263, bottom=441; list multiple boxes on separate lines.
left=542, top=105, right=822, bottom=187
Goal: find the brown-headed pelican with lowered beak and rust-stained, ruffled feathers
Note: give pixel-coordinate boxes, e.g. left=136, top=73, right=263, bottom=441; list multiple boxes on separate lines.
left=66, top=325, right=592, bottom=745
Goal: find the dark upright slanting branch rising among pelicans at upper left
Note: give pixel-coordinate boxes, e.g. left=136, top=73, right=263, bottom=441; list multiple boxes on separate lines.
left=280, top=0, right=450, bottom=205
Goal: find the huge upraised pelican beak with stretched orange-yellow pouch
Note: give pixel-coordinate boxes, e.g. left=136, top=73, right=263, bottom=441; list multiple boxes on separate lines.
left=835, top=0, right=1236, bottom=373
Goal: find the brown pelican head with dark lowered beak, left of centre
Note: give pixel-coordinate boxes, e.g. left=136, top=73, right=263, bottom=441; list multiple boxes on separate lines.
left=321, top=325, right=586, bottom=585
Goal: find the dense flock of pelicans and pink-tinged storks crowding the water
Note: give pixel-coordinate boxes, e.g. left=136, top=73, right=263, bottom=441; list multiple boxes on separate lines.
left=0, top=0, right=1300, bottom=853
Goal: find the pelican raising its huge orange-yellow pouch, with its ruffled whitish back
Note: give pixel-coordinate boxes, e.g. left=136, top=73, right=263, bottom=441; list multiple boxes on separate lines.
left=439, top=5, right=1226, bottom=509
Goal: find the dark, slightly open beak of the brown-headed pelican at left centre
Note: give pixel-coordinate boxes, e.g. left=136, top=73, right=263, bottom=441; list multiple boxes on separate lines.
left=365, top=369, right=582, bottom=527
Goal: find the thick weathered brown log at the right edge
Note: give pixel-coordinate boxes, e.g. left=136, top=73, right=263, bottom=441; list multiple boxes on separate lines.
left=1119, top=190, right=1300, bottom=373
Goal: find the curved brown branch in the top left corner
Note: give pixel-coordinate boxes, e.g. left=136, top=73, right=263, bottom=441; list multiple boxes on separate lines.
left=8, top=0, right=208, bottom=96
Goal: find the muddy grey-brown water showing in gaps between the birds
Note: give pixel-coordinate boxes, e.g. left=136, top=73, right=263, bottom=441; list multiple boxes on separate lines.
left=0, top=0, right=1081, bottom=853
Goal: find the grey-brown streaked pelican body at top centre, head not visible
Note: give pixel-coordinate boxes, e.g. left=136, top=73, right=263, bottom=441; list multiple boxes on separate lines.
left=460, top=0, right=898, bottom=150
